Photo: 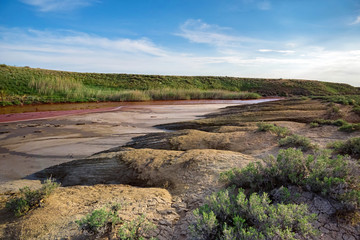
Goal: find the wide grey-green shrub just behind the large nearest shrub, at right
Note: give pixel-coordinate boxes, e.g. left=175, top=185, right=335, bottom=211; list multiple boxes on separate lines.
left=221, top=148, right=360, bottom=205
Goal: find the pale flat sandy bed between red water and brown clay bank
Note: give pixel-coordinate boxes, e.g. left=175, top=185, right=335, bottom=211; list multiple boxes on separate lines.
left=0, top=99, right=276, bottom=183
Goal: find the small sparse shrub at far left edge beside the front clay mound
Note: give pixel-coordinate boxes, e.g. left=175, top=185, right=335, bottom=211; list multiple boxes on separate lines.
left=6, top=179, right=60, bottom=217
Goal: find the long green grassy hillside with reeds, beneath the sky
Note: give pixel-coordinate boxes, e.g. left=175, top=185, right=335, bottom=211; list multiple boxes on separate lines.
left=0, top=64, right=360, bottom=105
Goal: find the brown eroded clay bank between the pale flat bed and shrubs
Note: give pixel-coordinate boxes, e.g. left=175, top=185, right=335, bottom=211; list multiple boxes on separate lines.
left=0, top=100, right=360, bottom=239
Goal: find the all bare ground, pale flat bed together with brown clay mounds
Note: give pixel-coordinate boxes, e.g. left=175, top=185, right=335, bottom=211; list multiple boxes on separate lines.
left=0, top=99, right=360, bottom=240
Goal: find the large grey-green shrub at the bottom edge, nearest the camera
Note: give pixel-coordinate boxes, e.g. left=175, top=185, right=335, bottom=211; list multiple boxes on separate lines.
left=190, top=188, right=316, bottom=239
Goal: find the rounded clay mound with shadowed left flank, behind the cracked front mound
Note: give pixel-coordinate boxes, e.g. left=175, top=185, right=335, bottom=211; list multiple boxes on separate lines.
left=35, top=148, right=256, bottom=194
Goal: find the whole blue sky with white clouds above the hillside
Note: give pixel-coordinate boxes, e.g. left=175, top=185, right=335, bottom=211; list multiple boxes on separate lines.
left=0, top=0, right=360, bottom=86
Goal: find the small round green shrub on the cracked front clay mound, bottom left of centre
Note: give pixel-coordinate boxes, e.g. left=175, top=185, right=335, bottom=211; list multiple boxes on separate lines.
left=75, top=208, right=120, bottom=236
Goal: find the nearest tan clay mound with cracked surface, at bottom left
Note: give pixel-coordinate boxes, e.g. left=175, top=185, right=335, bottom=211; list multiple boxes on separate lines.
left=0, top=185, right=179, bottom=239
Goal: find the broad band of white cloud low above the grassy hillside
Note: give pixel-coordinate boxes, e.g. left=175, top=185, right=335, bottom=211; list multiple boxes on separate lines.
left=0, top=25, right=360, bottom=86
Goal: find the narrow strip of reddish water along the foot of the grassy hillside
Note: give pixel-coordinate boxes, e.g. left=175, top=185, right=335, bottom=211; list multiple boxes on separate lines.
left=0, top=98, right=279, bottom=123
